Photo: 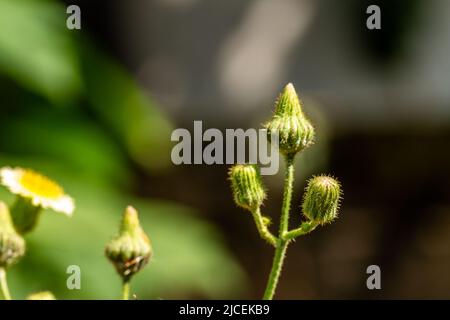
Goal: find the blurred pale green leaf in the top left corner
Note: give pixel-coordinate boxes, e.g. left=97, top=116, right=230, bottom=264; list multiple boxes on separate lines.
left=0, top=0, right=81, bottom=103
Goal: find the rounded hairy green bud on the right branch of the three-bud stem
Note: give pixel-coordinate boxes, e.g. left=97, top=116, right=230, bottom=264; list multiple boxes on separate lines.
left=302, top=176, right=341, bottom=224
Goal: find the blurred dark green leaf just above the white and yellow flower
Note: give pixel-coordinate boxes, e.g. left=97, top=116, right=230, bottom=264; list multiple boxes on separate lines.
left=0, top=107, right=130, bottom=185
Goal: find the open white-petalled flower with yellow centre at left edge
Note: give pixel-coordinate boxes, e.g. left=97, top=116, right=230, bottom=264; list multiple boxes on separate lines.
left=0, top=167, right=75, bottom=216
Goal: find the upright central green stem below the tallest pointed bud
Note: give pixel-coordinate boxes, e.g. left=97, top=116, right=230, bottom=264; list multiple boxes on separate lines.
left=263, top=156, right=294, bottom=300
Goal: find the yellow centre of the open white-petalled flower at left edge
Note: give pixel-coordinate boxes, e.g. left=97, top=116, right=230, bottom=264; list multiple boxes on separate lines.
left=20, top=170, right=64, bottom=198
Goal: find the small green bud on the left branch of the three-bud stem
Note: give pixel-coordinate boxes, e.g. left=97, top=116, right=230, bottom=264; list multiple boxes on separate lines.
left=229, top=164, right=266, bottom=211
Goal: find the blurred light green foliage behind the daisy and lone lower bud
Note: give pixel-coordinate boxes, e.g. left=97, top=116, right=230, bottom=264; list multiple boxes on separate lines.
left=0, top=157, right=243, bottom=299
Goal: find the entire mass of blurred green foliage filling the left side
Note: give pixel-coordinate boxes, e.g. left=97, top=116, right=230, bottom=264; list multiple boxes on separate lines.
left=0, top=0, right=245, bottom=299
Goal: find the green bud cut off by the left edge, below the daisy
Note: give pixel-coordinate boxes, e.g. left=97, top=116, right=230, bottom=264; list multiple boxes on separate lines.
left=0, top=202, right=25, bottom=268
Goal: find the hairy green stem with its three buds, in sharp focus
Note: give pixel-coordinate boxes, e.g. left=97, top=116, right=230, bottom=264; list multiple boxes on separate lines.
left=229, top=83, right=341, bottom=299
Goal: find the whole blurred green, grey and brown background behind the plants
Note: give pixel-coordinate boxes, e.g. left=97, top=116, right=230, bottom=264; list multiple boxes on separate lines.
left=0, top=0, right=450, bottom=299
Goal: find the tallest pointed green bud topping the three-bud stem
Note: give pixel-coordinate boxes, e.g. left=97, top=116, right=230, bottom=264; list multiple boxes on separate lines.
left=265, top=83, right=314, bottom=156
